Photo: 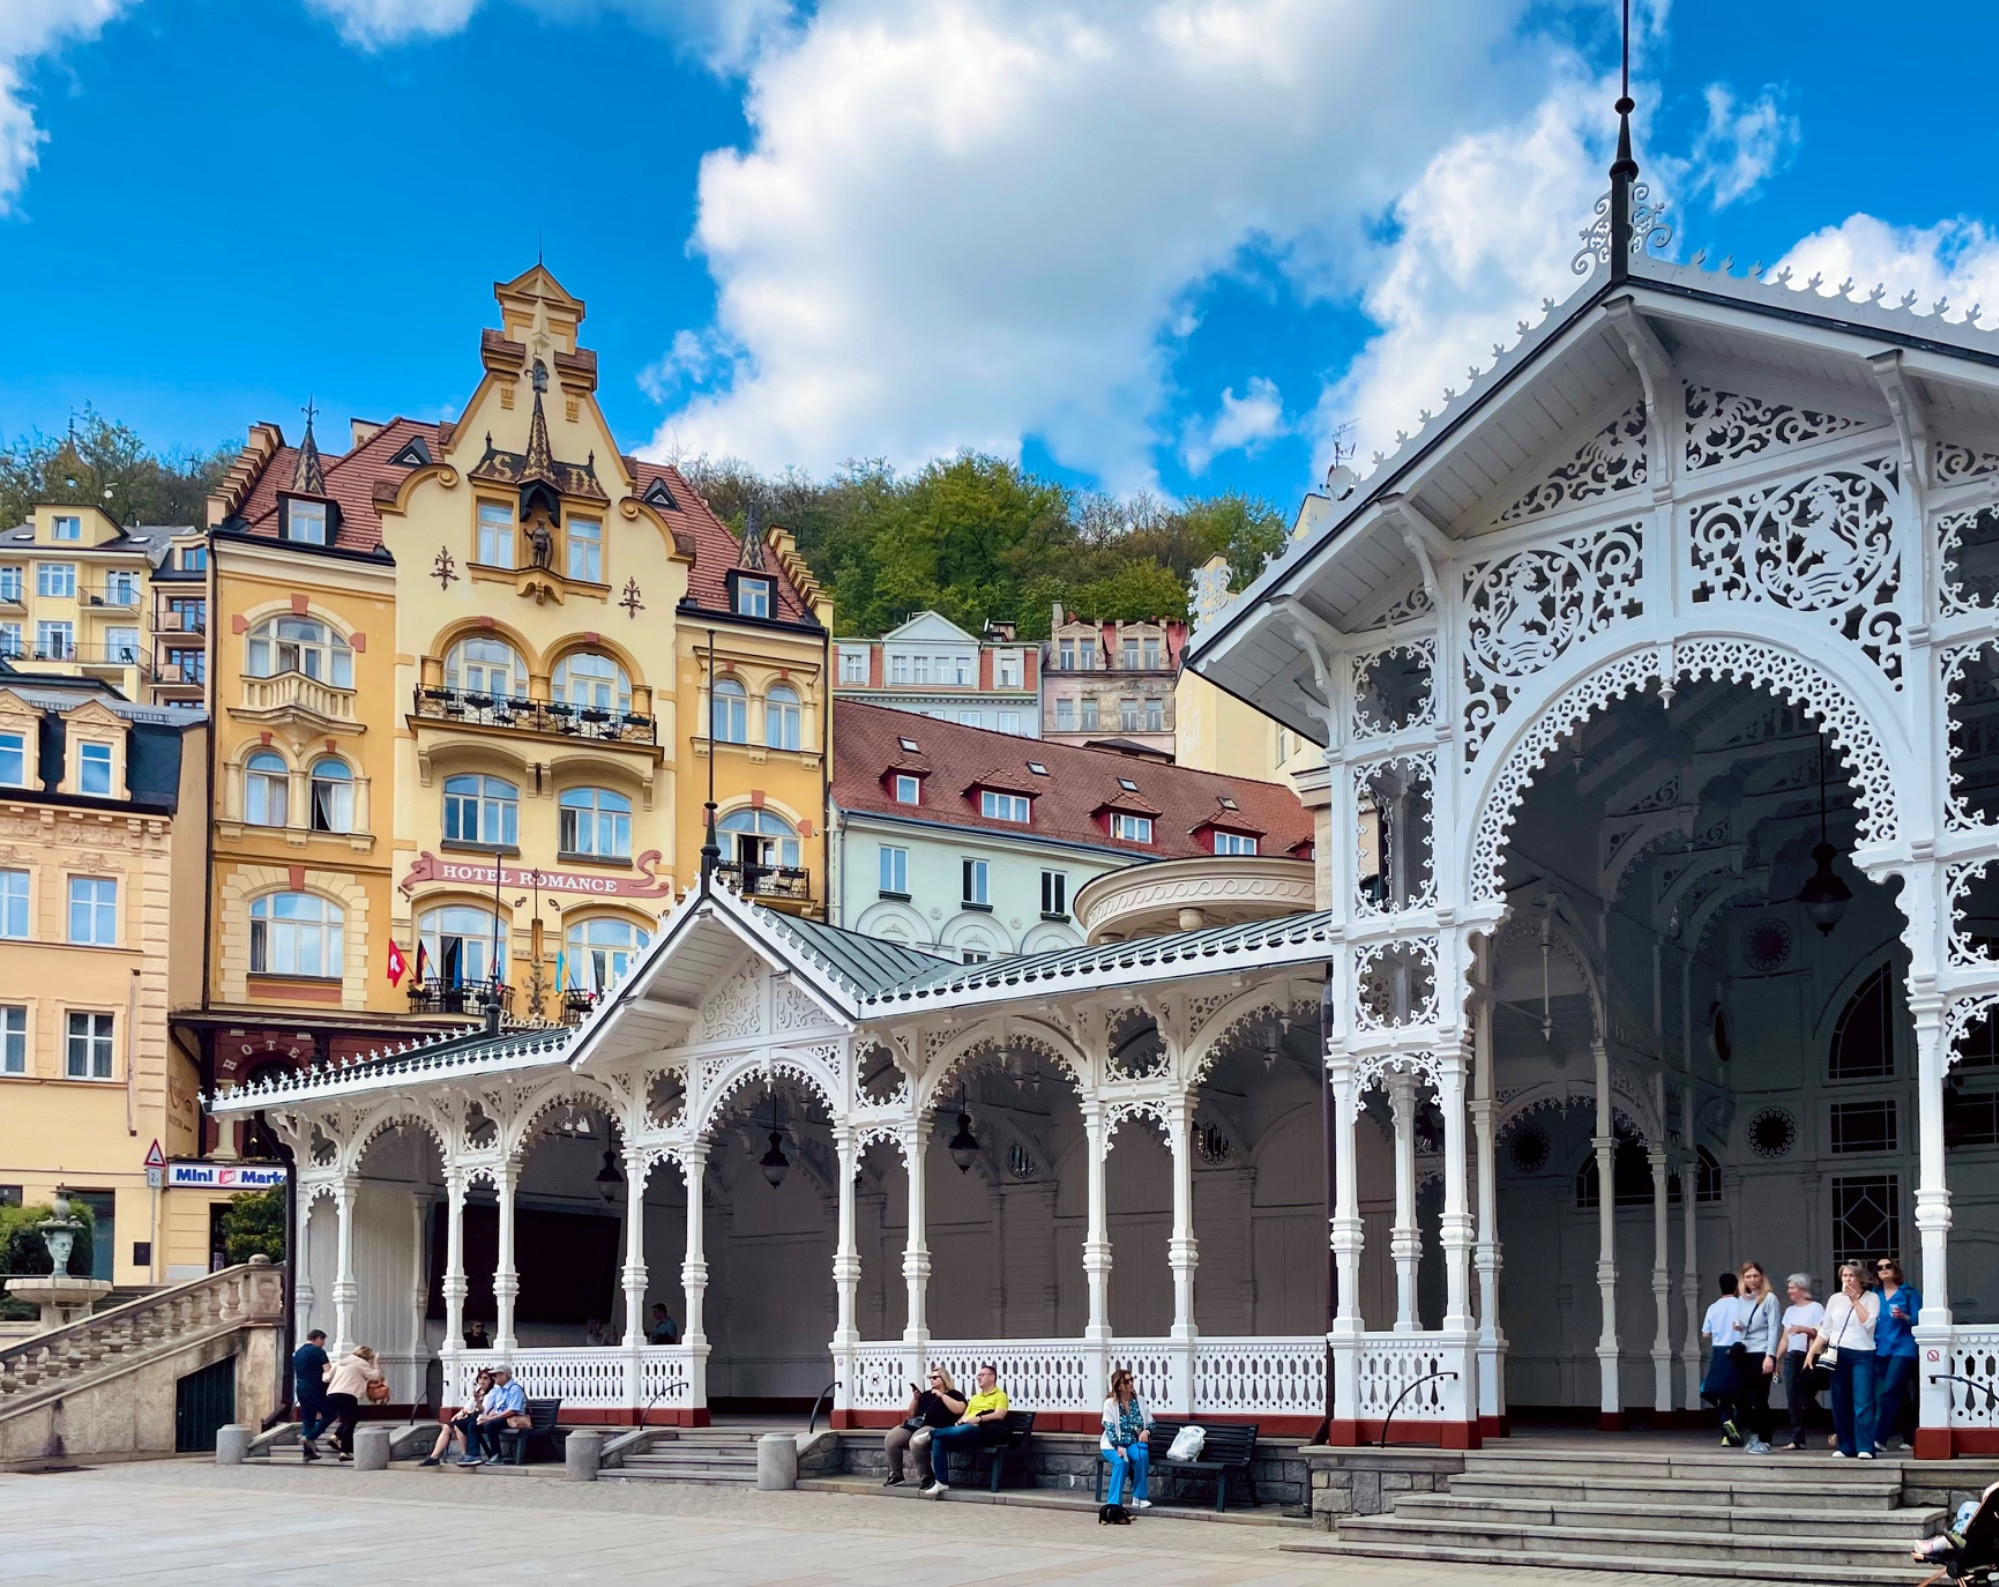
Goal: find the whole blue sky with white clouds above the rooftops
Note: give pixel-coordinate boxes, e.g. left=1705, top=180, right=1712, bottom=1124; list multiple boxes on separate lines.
left=0, top=0, right=1999, bottom=504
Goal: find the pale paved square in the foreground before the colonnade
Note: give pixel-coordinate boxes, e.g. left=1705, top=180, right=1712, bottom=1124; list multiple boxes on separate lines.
left=0, top=1459, right=1713, bottom=1587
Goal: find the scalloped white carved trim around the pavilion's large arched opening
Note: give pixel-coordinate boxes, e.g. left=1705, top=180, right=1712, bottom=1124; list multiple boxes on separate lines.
left=1467, top=631, right=1901, bottom=903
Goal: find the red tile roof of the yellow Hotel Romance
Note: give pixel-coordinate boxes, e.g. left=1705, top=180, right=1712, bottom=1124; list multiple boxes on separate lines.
left=210, top=420, right=814, bottom=624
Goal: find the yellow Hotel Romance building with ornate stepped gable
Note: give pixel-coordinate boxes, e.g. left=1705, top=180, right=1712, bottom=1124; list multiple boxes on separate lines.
left=184, top=266, right=832, bottom=1081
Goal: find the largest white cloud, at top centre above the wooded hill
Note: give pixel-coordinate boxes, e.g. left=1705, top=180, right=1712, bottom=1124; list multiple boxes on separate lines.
left=658, top=0, right=1559, bottom=488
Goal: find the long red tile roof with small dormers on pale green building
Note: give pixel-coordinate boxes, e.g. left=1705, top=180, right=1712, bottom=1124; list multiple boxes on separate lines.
left=834, top=696, right=1311, bottom=859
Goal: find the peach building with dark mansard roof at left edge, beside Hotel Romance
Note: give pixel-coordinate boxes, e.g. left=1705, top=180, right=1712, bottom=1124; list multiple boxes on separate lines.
left=0, top=666, right=216, bottom=1283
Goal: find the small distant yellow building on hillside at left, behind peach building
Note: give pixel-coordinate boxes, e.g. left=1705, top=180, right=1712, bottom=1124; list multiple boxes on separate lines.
left=0, top=504, right=200, bottom=704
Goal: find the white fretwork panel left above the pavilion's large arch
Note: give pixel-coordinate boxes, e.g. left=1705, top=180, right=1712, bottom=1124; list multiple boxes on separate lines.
left=1463, top=524, right=1645, bottom=768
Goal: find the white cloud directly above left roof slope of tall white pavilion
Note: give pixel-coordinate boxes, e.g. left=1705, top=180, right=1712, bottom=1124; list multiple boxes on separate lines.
left=1315, top=72, right=1615, bottom=468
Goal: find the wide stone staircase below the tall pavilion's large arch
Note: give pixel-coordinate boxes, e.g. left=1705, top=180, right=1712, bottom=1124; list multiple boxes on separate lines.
left=1283, top=1441, right=1945, bottom=1587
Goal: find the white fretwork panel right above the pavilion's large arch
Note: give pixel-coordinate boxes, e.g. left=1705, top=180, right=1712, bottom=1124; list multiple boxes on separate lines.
left=1689, top=462, right=1903, bottom=688
